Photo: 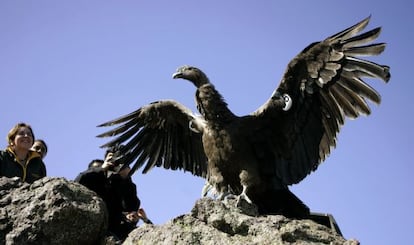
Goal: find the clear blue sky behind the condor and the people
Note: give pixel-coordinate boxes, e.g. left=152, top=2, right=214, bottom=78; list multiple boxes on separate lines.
left=0, top=0, right=414, bottom=244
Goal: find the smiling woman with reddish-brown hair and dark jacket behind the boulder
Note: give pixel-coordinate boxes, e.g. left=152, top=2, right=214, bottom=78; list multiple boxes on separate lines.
left=0, top=123, right=46, bottom=183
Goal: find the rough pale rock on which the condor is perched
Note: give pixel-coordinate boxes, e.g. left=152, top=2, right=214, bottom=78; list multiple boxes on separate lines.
left=124, top=198, right=359, bottom=245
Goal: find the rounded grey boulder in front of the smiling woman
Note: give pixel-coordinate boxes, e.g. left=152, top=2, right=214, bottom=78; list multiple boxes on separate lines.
left=0, top=177, right=107, bottom=244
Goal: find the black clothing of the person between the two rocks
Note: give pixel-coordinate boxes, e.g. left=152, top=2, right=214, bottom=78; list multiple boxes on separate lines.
left=75, top=167, right=141, bottom=240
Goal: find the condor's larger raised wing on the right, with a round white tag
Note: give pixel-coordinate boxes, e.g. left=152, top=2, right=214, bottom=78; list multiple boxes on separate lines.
left=252, top=17, right=390, bottom=185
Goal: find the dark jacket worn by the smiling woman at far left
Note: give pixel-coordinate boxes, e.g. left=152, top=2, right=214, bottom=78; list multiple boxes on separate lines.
left=0, top=148, right=46, bottom=183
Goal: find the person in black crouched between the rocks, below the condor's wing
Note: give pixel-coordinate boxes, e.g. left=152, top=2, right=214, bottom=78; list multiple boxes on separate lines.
left=75, top=146, right=141, bottom=241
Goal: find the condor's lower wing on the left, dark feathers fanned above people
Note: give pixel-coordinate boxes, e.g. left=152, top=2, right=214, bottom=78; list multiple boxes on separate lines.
left=97, top=100, right=207, bottom=177
